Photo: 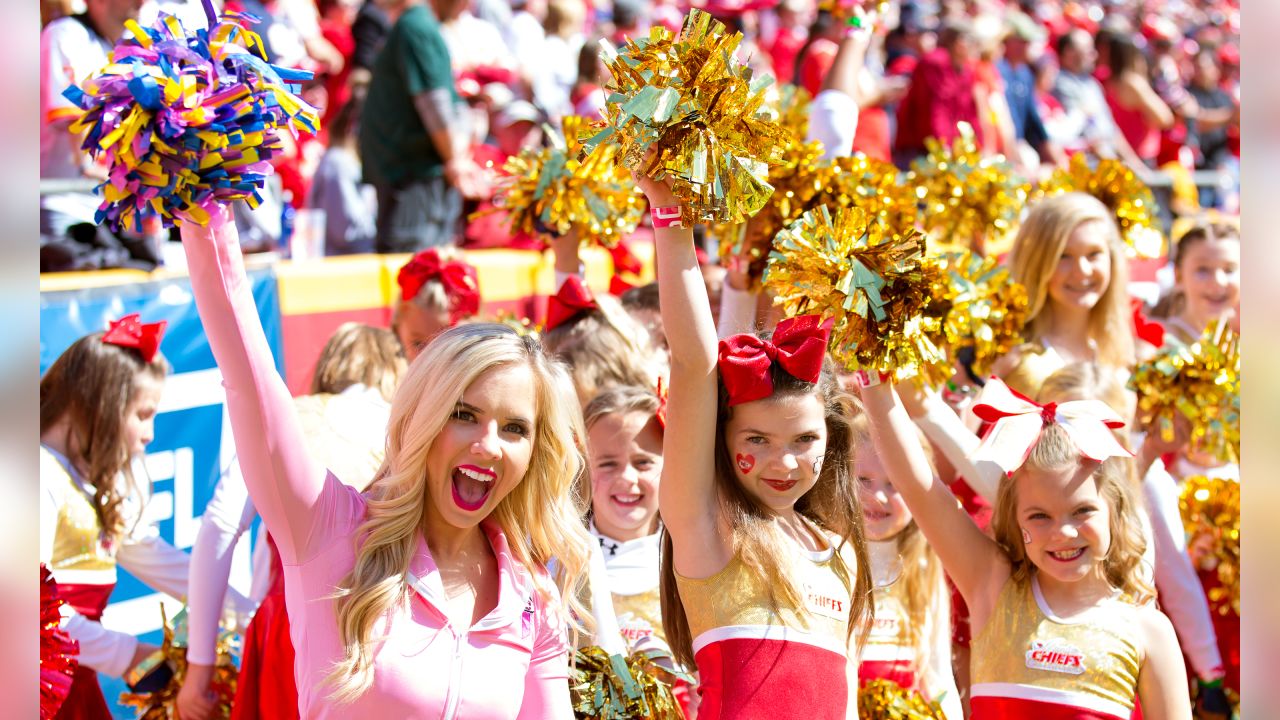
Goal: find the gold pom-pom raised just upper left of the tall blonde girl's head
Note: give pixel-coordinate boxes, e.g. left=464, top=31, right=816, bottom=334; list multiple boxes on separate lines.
left=909, top=123, right=1030, bottom=255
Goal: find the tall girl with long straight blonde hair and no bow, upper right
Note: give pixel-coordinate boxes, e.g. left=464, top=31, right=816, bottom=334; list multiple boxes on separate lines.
left=995, top=192, right=1134, bottom=396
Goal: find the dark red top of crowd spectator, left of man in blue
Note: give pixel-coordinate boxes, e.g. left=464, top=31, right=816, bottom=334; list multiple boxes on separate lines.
left=893, top=49, right=983, bottom=154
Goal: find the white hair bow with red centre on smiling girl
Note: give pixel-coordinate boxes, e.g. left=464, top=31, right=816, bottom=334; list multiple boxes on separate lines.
left=972, top=377, right=1133, bottom=474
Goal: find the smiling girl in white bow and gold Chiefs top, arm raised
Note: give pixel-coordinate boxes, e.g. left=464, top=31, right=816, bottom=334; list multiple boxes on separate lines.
left=859, top=373, right=1190, bottom=720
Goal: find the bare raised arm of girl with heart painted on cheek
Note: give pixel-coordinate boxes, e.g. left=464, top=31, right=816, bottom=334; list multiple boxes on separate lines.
left=636, top=174, right=731, bottom=578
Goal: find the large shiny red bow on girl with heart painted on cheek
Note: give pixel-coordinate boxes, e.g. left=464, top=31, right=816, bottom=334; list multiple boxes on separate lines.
left=719, top=315, right=831, bottom=407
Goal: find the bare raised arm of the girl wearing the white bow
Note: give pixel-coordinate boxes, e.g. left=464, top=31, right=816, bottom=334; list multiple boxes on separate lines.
left=861, top=380, right=1010, bottom=616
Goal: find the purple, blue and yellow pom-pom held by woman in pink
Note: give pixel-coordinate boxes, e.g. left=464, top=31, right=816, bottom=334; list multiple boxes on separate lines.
left=63, top=0, right=319, bottom=229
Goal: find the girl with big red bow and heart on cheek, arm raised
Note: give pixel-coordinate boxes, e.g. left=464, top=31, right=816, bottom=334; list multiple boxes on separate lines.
left=636, top=170, right=870, bottom=720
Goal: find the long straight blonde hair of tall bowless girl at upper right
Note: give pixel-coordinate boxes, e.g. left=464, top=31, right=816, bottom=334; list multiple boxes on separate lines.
left=1010, top=192, right=1134, bottom=368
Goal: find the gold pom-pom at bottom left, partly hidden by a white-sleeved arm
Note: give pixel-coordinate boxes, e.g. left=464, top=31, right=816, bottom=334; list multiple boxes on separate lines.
left=119, top=606, right=239, bottom=720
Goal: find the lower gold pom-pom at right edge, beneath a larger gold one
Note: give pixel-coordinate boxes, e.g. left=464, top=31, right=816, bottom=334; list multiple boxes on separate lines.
left=1178, top=475, right=1240, bottom=615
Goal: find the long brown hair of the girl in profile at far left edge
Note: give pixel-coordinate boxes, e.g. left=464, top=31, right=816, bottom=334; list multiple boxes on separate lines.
left=40, top=333, right=169, bottom=542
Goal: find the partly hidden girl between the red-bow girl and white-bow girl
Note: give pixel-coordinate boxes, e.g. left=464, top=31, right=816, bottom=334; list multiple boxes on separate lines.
left=852, top=415, right=964, bottom=720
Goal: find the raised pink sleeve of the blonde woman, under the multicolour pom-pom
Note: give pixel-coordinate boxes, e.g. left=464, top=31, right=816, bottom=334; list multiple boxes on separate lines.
left=182, top=208, right=329, bottom=564
